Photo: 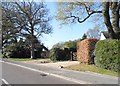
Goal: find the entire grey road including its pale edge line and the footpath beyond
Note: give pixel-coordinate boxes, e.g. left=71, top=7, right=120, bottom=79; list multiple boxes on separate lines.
left=0, top=59, right=119, bottom=86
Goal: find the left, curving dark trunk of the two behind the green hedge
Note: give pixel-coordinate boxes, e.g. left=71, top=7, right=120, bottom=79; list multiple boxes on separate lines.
left=103, top=2, right=116, bottom=39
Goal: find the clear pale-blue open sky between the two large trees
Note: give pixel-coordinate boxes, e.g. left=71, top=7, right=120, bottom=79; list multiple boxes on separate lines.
left=40, top=2, right=102, bottom=49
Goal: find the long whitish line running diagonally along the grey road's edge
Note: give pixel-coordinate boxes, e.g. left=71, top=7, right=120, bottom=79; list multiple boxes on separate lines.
left=2, top=62, right=92, bottom=84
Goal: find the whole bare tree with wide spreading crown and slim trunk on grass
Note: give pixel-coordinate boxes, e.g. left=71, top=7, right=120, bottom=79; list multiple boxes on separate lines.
left=3, top=1, right=52, bottom=58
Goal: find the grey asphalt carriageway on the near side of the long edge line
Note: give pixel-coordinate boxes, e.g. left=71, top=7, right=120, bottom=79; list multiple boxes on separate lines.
left=0, top=62, right=76, bottom=84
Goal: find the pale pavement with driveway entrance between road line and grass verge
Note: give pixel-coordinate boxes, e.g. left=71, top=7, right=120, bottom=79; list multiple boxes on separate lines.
left=1, top=60, right=120, bottom=85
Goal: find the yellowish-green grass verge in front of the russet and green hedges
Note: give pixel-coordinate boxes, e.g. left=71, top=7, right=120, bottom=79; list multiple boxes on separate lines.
left=66, top=64, right=120, bottom=76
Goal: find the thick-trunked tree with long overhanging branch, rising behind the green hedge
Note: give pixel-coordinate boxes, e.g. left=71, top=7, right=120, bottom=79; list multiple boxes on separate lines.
left=57, top=0, right=120, bottom=39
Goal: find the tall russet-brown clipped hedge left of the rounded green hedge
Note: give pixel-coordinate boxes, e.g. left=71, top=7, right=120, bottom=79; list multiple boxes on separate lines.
left=77, top=38, right=98, bottom=64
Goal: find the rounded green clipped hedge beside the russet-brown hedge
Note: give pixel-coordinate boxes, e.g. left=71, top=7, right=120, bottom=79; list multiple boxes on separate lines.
left=95, top=39, right=120, bottom=72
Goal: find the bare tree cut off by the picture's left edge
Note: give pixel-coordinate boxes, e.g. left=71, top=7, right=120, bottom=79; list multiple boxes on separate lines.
left=1, top=2, right=19, bottom=48
